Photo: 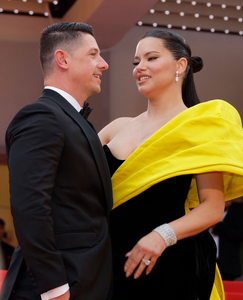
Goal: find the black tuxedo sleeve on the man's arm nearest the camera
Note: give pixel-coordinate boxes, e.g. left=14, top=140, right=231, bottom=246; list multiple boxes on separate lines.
left=6, top=103, right=68, bottom=294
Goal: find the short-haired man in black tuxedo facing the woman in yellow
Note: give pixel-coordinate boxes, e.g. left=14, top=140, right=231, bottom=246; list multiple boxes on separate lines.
left=2, top=22, right=112, bottom=300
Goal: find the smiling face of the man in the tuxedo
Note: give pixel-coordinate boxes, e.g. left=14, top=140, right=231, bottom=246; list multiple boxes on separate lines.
left=68, top=33, right=108, bottom=99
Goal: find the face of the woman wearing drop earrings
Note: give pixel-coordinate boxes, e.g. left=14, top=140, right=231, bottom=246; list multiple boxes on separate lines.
left=133, top=37, right=178, bottom=98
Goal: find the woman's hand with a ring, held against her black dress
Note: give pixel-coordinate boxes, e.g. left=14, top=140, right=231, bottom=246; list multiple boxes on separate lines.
left=124, top=231, right=166, bottom=279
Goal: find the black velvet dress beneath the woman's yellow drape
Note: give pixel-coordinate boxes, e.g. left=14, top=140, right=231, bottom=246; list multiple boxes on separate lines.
left=104, top=146, right=216, bottom=300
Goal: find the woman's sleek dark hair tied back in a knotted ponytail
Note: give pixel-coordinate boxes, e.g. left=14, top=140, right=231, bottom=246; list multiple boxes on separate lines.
left=141, top=29, right=203, bottom=107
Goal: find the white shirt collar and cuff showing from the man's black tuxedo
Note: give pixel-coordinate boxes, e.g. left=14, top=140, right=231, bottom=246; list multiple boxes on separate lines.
left=41, top=86, right=82, bottom=300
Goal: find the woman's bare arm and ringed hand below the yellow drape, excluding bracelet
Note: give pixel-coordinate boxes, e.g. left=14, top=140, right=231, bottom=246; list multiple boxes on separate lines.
left=124, top=172, right=225, bottom=279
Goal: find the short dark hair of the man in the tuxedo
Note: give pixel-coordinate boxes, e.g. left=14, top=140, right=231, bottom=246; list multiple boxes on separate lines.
left=40, top=22, right=94, bottom=76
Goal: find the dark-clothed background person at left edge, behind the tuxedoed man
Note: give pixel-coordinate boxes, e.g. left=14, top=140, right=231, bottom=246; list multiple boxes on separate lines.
left=0, top=219, right=14, bottom=270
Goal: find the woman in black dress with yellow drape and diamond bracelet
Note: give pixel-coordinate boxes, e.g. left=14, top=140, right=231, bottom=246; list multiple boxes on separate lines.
left=99, top=30, right=243, bottom=300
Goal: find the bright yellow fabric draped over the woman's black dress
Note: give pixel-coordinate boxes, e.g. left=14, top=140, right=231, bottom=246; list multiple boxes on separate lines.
left=112, top=100, right=243, bottom=300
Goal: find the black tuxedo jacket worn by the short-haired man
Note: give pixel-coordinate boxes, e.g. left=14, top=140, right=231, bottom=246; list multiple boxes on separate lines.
left=2, top=89, right=112, bottom=300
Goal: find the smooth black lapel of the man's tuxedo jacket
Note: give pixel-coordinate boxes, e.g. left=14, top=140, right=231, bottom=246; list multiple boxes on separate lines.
left=40, top=89, right=112, bottom=211
